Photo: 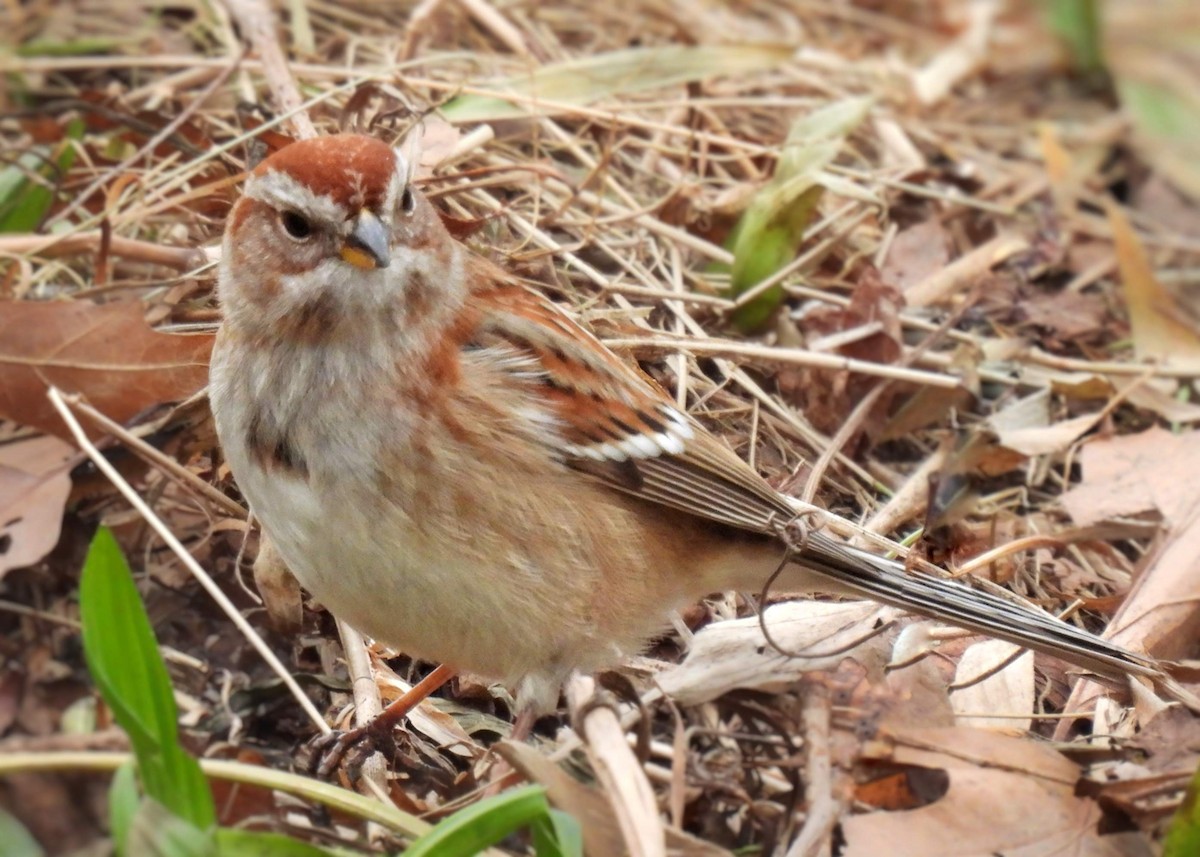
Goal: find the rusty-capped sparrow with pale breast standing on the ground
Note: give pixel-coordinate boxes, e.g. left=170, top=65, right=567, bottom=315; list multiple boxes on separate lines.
left=209, top=134, right=1158, bottom=753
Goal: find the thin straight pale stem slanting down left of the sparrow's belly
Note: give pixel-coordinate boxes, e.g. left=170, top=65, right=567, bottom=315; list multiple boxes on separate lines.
left=47, top=386, right=331, bottom=733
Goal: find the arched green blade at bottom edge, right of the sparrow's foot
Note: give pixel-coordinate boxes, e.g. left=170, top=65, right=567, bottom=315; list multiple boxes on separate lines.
left=403, top=786, right=566, bottom=857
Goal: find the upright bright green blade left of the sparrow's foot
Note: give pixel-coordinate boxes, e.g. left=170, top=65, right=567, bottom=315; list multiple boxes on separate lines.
left=79, top=528, right=216, bottom=825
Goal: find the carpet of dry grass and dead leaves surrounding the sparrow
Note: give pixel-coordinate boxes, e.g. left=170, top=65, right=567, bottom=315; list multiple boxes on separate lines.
left=0, top=0, right=1200, bottom=855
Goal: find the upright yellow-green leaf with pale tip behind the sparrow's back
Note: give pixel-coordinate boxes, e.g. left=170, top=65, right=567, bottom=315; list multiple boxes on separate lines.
left=726, top=97, right=872, bottom=332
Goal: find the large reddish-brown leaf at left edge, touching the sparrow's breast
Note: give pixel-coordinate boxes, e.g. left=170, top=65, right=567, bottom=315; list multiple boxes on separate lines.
left=0, top=301, right=214, bottom=437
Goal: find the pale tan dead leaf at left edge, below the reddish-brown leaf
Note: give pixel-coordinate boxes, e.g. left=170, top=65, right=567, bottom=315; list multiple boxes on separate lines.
left=0, top=437, right=74, bottom=575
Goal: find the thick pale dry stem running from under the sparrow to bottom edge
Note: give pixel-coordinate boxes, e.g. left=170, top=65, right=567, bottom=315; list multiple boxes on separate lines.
left=566, top=675, right=666, bottom=857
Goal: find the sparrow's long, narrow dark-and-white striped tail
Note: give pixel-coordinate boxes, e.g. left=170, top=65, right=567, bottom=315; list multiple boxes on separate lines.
left=796, top=533, right=1156, bottom=676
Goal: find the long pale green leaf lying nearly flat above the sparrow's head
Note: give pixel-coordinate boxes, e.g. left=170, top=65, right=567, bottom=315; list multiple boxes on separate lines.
left=440, top=44, right=793, bottom=122
